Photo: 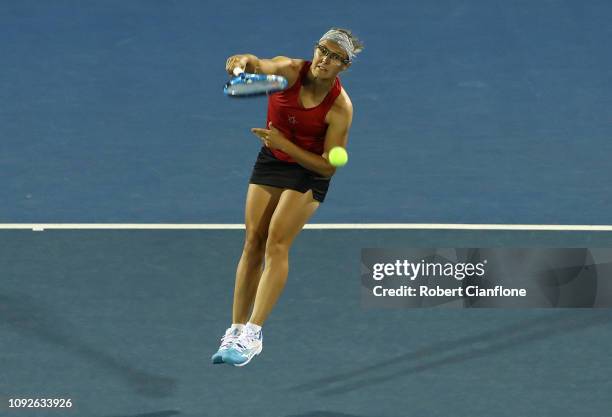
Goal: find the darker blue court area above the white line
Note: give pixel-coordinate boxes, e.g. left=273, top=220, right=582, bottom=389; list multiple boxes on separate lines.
left=0, top=0, right=612, bottom=224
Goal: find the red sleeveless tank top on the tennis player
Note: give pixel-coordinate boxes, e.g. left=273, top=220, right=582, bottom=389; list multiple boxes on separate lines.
left=266, top=61, right=342, bottom=162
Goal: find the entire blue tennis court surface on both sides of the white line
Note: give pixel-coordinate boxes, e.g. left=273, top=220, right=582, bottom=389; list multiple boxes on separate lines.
left=0, top=0, right=612, bottom=417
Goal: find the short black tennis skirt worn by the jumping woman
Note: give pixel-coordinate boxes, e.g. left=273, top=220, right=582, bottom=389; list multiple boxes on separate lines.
left=249, top=146, right=330, bottom=203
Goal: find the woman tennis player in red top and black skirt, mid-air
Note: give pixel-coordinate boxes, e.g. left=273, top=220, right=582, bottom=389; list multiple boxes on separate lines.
left=212, top=28, right=363, bottom=366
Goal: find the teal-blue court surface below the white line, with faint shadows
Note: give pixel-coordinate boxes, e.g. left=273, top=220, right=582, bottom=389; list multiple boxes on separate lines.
left=0, top=230, right=612, bottom=417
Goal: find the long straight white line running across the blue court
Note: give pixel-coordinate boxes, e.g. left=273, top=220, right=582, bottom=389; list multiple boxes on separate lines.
left=0, top=223, right=612, bottom=232
